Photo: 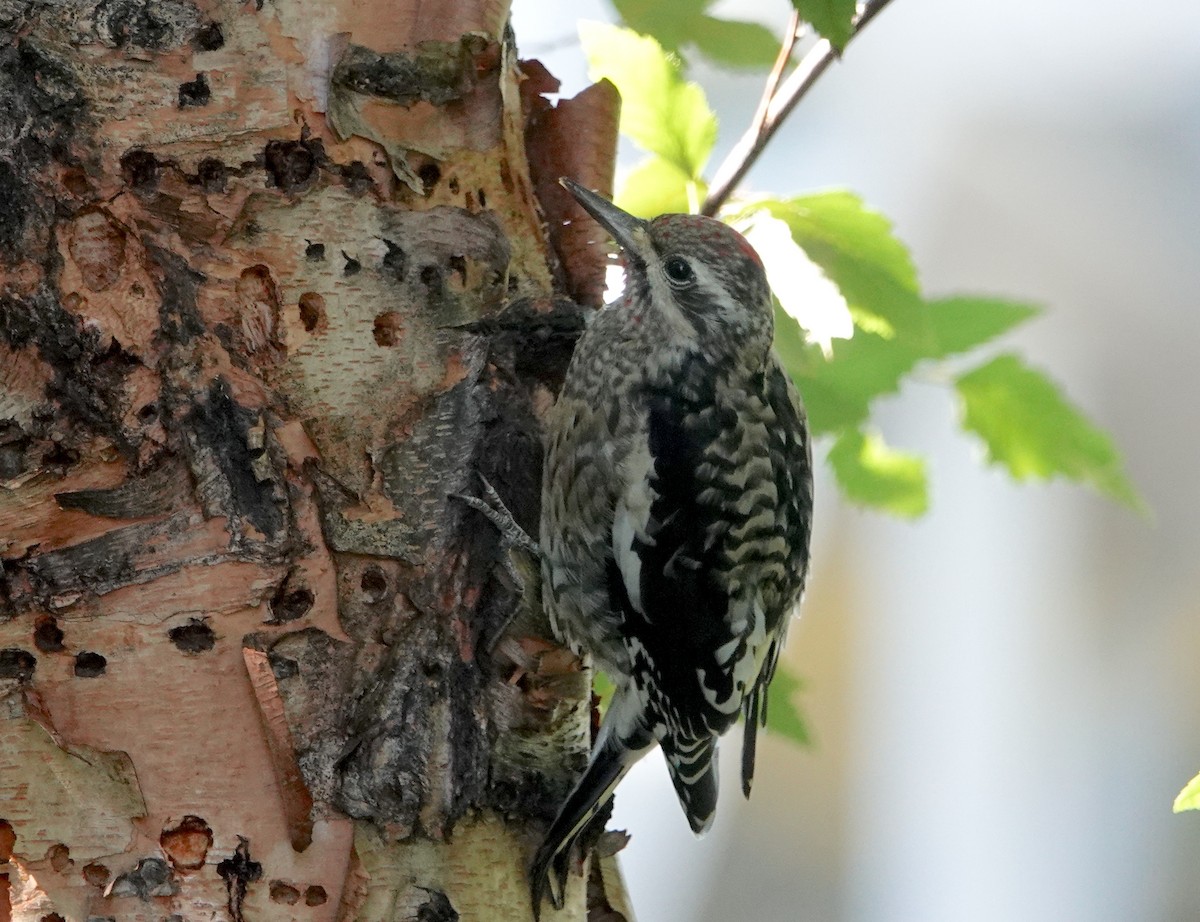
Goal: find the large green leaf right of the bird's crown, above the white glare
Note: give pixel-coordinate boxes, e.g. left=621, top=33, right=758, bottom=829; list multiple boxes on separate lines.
left=754, top=191, right=935, bottom=352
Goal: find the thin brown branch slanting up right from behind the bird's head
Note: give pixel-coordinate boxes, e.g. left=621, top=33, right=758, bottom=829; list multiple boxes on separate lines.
left=701, top=0, right=892, bottom=217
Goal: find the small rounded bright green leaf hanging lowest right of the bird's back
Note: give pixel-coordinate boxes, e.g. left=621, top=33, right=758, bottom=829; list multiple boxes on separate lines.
left=829, top=430, right=929, bottom=519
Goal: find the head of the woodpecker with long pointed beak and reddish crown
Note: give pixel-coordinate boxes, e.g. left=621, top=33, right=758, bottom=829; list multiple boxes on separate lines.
left=559, top=179, right=774, bottom=361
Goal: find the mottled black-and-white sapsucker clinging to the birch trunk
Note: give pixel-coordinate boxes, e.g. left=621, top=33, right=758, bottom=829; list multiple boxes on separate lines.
left=530, top=179, right=812, bottom=910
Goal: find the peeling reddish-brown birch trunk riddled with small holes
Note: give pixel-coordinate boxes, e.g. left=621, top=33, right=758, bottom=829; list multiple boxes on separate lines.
left=0, top=0, right=628, bottom=922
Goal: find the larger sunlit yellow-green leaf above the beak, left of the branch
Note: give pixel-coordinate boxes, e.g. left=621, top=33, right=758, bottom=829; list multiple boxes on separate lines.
left=580, top=23, right=716, bottom=179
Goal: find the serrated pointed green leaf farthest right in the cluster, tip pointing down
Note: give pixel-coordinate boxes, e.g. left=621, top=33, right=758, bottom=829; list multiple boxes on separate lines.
left=955, top=354, right=1145, bottom=510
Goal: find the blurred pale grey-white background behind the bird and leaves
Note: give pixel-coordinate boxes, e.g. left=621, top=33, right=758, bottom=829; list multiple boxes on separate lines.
left=514, top=0, right=1200, bottom=922
